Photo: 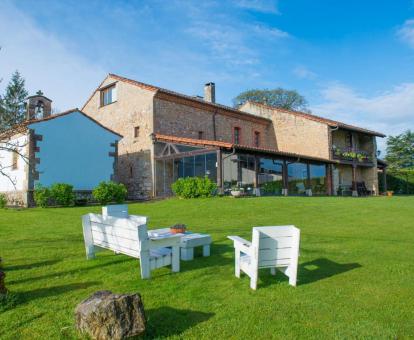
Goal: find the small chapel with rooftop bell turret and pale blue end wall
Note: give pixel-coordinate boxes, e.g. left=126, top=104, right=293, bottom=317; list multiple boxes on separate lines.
left=0, top=93, right=122, bottom=206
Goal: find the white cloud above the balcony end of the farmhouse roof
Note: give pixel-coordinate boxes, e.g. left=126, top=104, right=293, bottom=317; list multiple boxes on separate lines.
left=311, top=83, right=414, bottom=150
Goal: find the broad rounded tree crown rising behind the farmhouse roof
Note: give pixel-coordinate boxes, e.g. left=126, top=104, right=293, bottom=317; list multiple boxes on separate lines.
left=233, top=87, right=310, bottom=112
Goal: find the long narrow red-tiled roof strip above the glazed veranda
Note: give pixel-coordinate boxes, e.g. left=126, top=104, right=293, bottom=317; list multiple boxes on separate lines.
left=153, top=133, right=337, bottom=163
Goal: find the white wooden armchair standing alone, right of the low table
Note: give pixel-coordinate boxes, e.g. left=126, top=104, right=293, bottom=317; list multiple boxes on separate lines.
left=228, top=225, right=300, bottom=289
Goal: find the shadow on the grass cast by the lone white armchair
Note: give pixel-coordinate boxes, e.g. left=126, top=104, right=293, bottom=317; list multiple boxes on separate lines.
left=259, top=258, right=362, bottom=287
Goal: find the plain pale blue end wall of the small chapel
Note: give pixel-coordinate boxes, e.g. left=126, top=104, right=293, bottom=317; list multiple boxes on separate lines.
left=30, top=112, right=119, bottom=190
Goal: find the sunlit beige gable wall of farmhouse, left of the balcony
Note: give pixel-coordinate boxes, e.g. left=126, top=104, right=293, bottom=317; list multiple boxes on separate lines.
left=240, top=102, right=330, bottom=159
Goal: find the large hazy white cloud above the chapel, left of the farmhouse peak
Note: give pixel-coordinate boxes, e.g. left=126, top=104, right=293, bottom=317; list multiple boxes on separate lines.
left=0, top=1, right=106, bottom=111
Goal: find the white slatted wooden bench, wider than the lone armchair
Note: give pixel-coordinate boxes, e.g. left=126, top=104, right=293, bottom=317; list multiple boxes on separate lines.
left=82, top=214, right=181, bottom=279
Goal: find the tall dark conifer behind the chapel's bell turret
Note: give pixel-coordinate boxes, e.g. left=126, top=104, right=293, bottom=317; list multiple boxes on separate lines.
left=0, top=71, right=28, bottom=129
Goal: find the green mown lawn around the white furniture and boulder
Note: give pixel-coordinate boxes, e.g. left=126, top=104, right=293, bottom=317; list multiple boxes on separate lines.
left=0, top=197, right=414, bottom=339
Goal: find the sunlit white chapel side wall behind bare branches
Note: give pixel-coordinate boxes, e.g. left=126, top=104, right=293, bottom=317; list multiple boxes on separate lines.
left=0, top=135, right=27, bottom=192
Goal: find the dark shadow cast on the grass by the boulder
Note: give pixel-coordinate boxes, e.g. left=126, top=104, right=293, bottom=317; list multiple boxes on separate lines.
left=144, top=307, right=214, bottom=339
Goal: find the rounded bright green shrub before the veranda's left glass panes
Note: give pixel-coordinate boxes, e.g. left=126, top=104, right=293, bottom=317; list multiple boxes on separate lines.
left=171, top=176, right=217, bottom=198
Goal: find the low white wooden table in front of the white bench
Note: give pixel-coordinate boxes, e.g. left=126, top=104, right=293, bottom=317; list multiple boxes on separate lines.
left=148, top=228, right=211, bottom=261
